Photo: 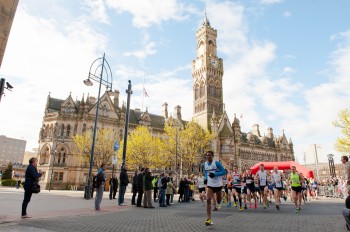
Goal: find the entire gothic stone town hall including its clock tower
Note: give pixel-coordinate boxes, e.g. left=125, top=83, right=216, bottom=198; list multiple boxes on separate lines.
left=38, top=17, right=294, bottom=189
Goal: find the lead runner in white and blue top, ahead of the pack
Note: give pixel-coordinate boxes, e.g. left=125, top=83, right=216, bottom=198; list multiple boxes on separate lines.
left=203, top=151, right=226, bottom=226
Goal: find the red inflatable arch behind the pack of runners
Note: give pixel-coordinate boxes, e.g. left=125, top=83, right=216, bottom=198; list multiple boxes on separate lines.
left=250, top=161, right=314, bottom=179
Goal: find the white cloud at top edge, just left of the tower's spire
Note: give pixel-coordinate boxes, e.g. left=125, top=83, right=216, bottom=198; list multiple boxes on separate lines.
left=107, top=0, right=186, bottom=28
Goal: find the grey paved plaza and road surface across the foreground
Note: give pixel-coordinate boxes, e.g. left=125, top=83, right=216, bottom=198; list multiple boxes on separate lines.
left=0, top=188, right=345, bottom=232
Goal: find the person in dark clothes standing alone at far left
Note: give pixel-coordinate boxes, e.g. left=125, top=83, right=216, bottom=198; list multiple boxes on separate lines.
left=22, top=157, right=42, bottom=218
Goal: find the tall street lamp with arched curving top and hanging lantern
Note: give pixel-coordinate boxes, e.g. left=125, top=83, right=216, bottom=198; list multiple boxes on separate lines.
left=84, top=54, right=112, bottom=199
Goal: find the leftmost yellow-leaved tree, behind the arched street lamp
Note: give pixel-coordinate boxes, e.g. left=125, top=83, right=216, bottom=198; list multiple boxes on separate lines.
left=73, top=128, right=118, bottom=167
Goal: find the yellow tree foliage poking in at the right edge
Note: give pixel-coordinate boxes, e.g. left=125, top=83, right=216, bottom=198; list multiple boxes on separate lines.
left=333, top=109, right=350, bottom=153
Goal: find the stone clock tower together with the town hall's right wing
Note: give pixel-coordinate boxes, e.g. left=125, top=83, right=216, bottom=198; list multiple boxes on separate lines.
left=192, top=17, right=294, bottom=170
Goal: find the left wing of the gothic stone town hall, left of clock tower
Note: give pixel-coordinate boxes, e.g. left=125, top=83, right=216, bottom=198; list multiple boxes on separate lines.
left=38, top=91, right=183, bottom=189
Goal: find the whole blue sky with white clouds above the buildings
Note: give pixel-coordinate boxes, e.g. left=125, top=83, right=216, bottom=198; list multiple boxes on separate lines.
left=0, top=0, right=350, bottom=162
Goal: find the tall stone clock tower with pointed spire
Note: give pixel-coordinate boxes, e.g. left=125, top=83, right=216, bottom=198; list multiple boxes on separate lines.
left=192, top=15, right=224, bottom=130
